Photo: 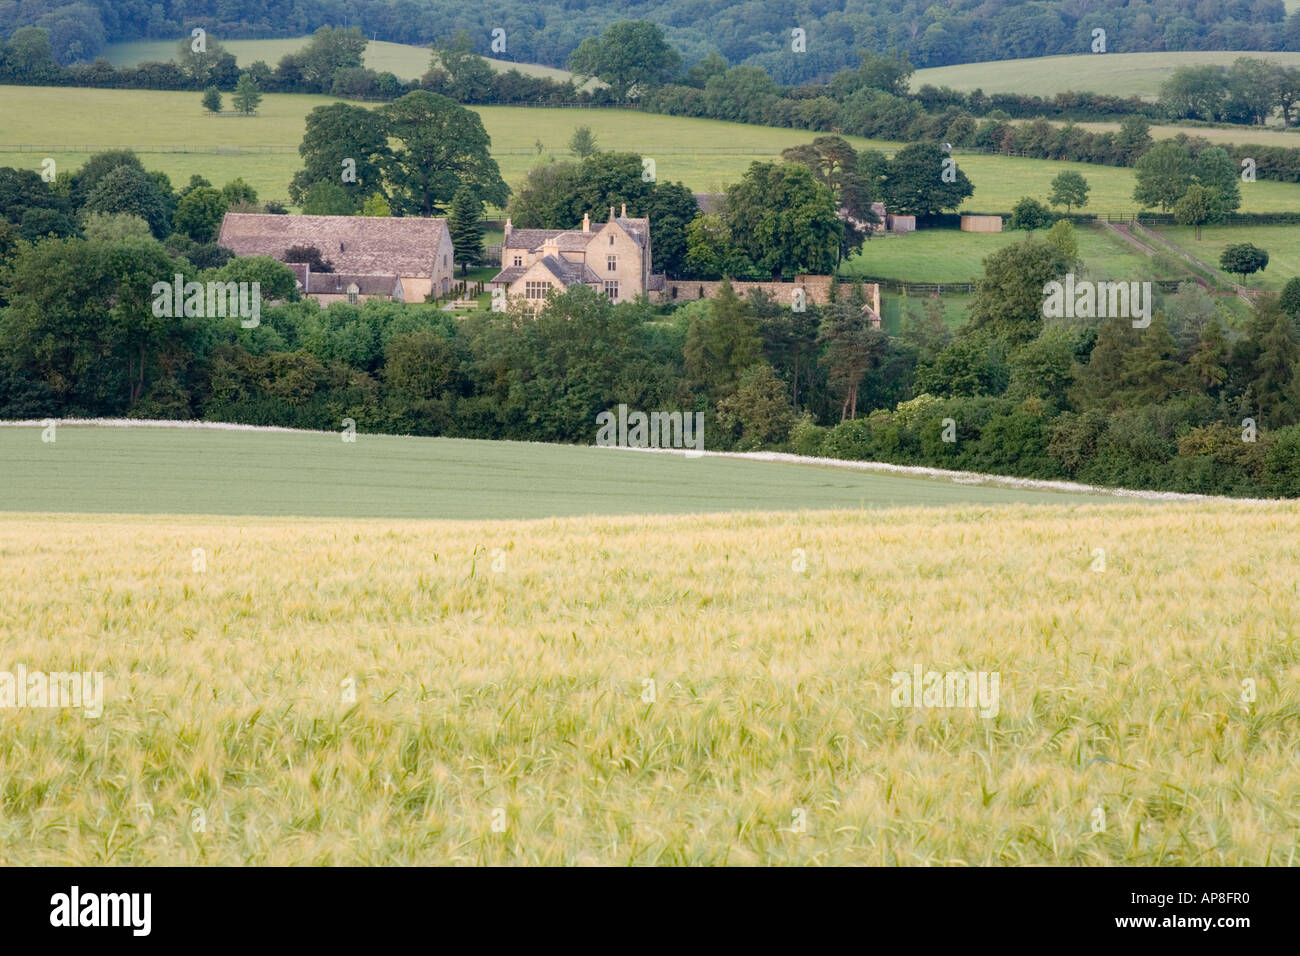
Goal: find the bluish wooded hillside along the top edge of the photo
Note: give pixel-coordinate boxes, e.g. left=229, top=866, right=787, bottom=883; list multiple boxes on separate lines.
left=0, top=0, right=1300, bottom=83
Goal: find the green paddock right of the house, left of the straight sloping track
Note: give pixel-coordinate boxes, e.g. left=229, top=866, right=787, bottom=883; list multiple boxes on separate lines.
left=842, top=228, right=1188, bottom=282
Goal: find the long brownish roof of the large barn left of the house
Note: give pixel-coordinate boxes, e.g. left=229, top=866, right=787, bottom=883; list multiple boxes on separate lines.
left=217, top=212, right=450, bottom=280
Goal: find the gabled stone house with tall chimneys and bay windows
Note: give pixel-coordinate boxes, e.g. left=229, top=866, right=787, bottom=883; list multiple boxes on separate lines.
left=489, top=204, right=664, bottom=308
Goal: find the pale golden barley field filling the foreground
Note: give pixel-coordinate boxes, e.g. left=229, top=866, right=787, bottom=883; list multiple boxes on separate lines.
left=0, top=502, right=1300, bottom=865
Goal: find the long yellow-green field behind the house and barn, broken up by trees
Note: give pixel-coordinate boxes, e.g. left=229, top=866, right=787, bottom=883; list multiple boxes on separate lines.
left=0, top=87, right=1300, bottom=213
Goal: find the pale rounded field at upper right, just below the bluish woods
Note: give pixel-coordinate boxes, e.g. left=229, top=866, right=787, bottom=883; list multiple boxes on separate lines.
left=911, top=51, right=1300, bottom=99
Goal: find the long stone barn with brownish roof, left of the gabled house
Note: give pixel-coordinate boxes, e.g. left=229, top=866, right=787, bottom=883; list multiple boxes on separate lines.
left=217, top=212, right=456, bottom=306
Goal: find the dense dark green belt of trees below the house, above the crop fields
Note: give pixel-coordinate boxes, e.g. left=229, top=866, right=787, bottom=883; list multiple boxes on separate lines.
left=0, top=222, right=1300, bottom=496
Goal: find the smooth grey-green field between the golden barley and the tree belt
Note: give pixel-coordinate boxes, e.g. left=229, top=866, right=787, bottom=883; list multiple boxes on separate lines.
left=0, top=423, right=1104, bottom=519
